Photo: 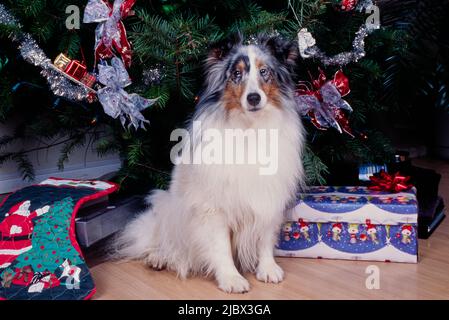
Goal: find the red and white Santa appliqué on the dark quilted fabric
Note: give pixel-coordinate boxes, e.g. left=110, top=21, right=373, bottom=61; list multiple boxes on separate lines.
left=0, top=200, right=50, bottom=269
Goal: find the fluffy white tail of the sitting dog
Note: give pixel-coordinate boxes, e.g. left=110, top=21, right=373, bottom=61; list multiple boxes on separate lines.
left=110, top=190, right=171, bottom=268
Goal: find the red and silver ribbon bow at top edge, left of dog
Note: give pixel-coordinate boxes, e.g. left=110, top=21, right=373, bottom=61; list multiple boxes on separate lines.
left=83, top=0, right=136, bottom=68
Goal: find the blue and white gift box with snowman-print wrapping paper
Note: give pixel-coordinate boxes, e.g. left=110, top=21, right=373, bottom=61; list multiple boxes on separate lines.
left=275, top=186, right=418, bottom=263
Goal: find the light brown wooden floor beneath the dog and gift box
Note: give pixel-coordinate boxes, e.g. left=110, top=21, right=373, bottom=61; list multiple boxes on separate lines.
left=89, top=159, right=449, bottom=299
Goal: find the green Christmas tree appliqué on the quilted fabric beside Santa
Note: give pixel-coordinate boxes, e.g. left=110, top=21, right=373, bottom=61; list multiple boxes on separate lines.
left=14, top=197, right=83, bottom=273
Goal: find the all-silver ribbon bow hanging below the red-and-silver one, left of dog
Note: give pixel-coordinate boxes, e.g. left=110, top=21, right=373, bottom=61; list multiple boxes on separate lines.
left=97, top=57, right=157, bottom=129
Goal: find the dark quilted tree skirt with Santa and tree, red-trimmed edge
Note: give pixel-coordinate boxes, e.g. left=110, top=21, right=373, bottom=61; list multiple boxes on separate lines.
left=0, top=178, right=118, bottom=300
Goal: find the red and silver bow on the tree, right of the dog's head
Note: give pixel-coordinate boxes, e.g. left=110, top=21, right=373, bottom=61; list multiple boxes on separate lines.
left=296, top=69, right=354, bottom=137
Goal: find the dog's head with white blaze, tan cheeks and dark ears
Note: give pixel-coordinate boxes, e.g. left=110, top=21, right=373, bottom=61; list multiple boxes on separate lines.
left=206, top=34, right=297, bottom=113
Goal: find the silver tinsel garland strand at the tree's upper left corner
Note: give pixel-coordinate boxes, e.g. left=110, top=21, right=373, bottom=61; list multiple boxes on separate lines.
left=0, top=4, right=89, bottom=101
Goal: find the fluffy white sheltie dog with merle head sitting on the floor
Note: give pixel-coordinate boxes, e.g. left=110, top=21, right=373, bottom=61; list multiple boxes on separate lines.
left=114, top=36, right=304, bottom=293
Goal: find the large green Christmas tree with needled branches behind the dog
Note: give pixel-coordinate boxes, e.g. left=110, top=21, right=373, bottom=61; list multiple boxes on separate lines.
left=0, top=0, right=449, bottom=188
